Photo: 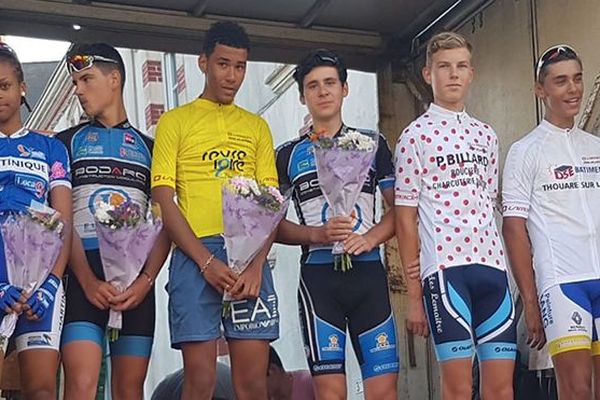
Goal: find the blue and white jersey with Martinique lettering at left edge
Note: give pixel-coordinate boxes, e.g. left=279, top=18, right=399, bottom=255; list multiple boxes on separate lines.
left=0, top=128, right=71, bottom=212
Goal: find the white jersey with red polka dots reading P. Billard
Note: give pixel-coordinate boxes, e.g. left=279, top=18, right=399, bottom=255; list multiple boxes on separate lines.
left=395, top=104, right=506, bottom=278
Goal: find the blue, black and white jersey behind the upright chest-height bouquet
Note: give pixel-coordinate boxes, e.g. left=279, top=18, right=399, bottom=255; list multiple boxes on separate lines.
left=277, top=125, right=394, bottom=264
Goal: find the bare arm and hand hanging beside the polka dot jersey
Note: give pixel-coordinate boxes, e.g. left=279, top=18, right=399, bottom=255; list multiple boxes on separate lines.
left=395, top=206, right=429, bottom=337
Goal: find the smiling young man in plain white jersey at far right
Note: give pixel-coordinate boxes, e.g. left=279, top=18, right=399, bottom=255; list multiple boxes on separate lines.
left=502, top=45, right=600, bottom=400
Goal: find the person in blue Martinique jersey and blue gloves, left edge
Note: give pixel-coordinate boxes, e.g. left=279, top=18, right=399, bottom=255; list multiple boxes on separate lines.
left=0, top=42, right=72, bottom=399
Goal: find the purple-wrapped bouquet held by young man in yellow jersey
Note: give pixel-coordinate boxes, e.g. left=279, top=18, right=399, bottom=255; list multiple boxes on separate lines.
left=223, top=176, right=289, bottom=308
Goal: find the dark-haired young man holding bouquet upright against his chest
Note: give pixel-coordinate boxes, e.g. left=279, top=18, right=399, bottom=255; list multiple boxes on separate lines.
left=276, top=49, right=399, bottom=400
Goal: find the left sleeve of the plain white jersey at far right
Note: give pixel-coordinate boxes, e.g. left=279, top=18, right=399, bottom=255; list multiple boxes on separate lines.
left=502, top=139, right=535, bottom=219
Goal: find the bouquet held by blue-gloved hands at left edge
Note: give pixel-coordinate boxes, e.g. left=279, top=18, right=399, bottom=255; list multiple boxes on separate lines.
left=0, top=203, right=65, bottom=339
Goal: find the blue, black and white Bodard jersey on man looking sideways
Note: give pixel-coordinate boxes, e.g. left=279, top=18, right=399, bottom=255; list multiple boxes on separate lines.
left=57, top=121, right=152, bottom=250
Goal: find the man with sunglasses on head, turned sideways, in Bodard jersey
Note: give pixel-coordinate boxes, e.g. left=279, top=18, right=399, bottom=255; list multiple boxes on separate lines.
left=58, top=43, right=169, bottom=400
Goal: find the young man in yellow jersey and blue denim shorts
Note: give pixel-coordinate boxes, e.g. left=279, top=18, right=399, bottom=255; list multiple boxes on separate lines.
left=152, top=22, right=279, bottom=400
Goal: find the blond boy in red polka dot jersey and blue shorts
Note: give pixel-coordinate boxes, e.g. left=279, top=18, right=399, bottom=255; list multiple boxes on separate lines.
left=394, top=32, right=516, bottom=399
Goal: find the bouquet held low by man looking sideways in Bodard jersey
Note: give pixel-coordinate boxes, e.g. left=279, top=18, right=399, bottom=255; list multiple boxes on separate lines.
left=94, top=200, right=162, bottom=341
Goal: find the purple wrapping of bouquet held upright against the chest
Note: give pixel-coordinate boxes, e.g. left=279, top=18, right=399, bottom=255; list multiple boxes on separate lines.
left=314, top=145, right=377, bottom=254
